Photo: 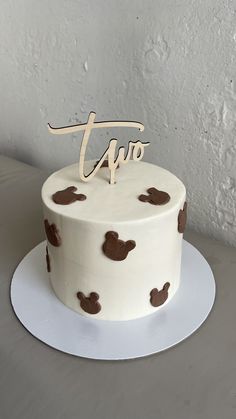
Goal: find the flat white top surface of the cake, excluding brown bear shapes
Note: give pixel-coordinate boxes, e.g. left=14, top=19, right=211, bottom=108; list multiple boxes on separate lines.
left=42, top=160, right=186, bottom=224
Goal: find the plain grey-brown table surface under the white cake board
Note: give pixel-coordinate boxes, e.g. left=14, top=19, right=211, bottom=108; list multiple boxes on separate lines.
left=0, top=156, right=236, bottom=419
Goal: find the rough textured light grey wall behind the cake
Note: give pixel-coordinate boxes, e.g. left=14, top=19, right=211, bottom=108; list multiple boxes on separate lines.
left=0, top=0, right=236, bottom=245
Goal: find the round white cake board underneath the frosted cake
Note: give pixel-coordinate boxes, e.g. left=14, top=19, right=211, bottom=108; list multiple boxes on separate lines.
left=11, top=241, right=215, bottom=360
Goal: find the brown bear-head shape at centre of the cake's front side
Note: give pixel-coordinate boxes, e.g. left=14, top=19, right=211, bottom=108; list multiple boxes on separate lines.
left=102, top=231, right=136, bottom=260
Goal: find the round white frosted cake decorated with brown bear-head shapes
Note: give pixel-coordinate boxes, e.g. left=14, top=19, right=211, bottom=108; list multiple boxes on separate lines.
left=42, top=161, right=187, bottom=320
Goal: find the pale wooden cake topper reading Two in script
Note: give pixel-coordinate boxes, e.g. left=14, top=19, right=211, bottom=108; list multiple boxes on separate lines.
left=48, top=112, right=150, bottom=184
